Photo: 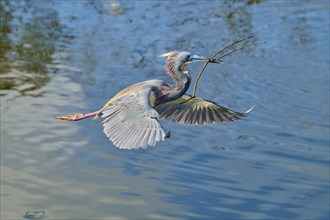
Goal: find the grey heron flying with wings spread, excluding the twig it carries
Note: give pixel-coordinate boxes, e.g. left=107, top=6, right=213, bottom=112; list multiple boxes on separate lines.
left=56, top=51, right=252, bottom=149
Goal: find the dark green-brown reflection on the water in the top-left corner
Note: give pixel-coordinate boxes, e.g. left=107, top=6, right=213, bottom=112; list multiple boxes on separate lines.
left=0, top=0, right=73, bottom=96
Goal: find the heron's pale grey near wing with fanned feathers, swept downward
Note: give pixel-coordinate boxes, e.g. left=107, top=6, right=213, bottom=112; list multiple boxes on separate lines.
left=99, top=84, right=165, bottom=149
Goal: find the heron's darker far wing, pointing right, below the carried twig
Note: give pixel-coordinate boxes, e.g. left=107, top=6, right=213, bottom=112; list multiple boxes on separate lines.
left=155, top=95, right=253, bottom=125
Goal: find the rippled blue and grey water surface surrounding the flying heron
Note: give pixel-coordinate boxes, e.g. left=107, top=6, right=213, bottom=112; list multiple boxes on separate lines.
left=0, top=0, right=330, bottom=219
